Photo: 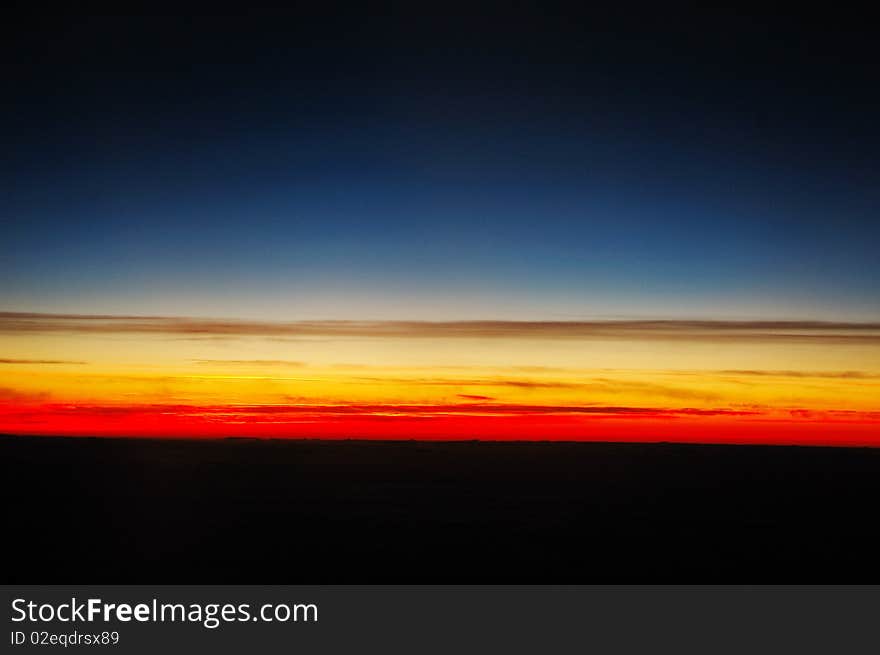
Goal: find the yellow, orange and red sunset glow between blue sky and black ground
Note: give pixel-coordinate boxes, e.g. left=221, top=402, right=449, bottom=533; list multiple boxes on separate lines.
left=0, top=313, right=880, bottom=445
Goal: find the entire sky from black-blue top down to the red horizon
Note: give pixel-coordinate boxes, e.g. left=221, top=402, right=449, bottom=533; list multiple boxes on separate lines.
left=0, top=3, right=880, bottom=444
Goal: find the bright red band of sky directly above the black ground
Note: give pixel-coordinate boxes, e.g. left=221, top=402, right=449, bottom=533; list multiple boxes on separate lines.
left=0, top=404, right=880, bottom=446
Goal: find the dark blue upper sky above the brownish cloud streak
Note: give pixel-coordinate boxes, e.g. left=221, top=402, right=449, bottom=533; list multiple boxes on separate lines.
left=0, top=8, right=880, bottom=319
